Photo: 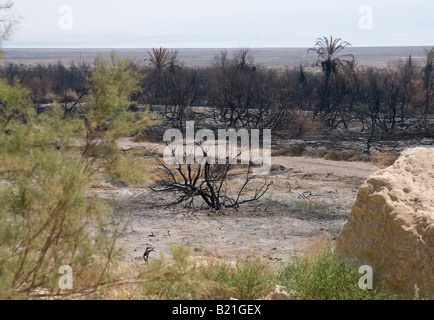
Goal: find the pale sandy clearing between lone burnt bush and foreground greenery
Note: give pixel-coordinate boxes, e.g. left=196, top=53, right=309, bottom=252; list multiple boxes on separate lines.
left=93, top=141, right=380, bottom=261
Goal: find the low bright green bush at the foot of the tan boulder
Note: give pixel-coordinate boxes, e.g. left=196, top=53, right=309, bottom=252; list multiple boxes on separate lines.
left=279, top=247, right=391, bottom=300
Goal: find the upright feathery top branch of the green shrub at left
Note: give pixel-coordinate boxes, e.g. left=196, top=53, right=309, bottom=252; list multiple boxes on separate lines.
left=83, top=54, right=151, bottom=183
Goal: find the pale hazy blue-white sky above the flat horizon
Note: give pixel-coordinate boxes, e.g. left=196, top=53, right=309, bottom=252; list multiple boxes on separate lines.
left=5, top=0, right=434, bottom=48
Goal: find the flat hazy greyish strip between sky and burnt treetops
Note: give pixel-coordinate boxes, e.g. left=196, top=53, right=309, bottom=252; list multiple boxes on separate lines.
left=1, top=47, right=428, bottom=68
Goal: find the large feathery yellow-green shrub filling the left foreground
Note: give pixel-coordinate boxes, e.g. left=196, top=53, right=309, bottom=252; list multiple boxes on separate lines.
left=0, top=51, right=153, bottom=298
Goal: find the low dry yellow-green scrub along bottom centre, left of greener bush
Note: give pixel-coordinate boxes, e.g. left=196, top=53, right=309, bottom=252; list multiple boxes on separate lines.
left=142, top=246, right=276, bottom=300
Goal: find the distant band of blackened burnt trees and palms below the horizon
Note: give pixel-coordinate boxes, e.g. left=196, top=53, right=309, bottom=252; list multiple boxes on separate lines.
left=0, top=37, right=434, bottom=152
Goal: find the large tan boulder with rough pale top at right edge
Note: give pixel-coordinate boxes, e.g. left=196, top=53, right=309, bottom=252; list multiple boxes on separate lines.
left=336, top=148, right=434, bottom=299
